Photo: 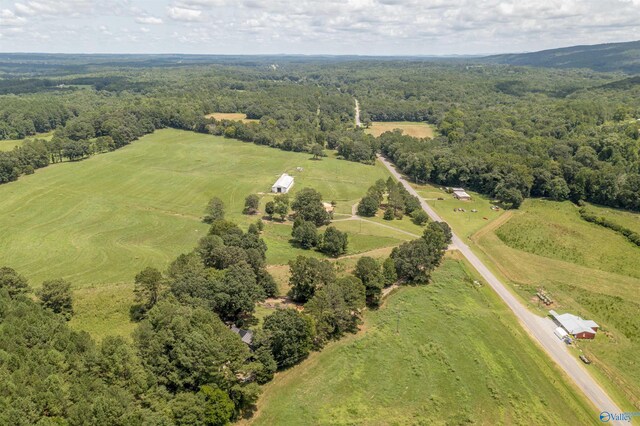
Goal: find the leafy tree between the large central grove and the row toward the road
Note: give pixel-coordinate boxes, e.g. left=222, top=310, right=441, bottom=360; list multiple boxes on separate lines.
left=289, top=256, right=336, bottom=303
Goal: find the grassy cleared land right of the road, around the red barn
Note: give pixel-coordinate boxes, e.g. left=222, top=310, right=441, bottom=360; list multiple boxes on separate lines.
left=416, top=185, right=640, bottom=411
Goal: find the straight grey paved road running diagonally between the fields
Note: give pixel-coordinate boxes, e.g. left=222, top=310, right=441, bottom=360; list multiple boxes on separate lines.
left=378, top=156, right=628, bottom=424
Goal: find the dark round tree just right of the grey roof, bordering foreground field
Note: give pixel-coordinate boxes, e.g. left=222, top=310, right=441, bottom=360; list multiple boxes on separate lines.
left=262, top=309, right=314, bottom=368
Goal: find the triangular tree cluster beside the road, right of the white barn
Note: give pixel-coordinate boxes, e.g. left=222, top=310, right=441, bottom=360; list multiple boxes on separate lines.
left=357, top=177, right=429, bottom=225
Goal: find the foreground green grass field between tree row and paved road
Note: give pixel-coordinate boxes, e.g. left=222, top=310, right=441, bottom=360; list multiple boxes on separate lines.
left=247, top=259, right=597, bottom=425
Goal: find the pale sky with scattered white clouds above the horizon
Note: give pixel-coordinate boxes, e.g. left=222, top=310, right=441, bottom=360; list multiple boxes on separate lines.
left=0, top=0, right=640, bottom=55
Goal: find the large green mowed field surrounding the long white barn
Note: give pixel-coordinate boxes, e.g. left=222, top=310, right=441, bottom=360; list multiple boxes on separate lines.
left=0, top=130, right=400, bottom=337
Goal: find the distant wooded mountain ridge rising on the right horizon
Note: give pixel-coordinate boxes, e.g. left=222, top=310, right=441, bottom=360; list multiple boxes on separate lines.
left=481, top=41, right=640, bottom=74
